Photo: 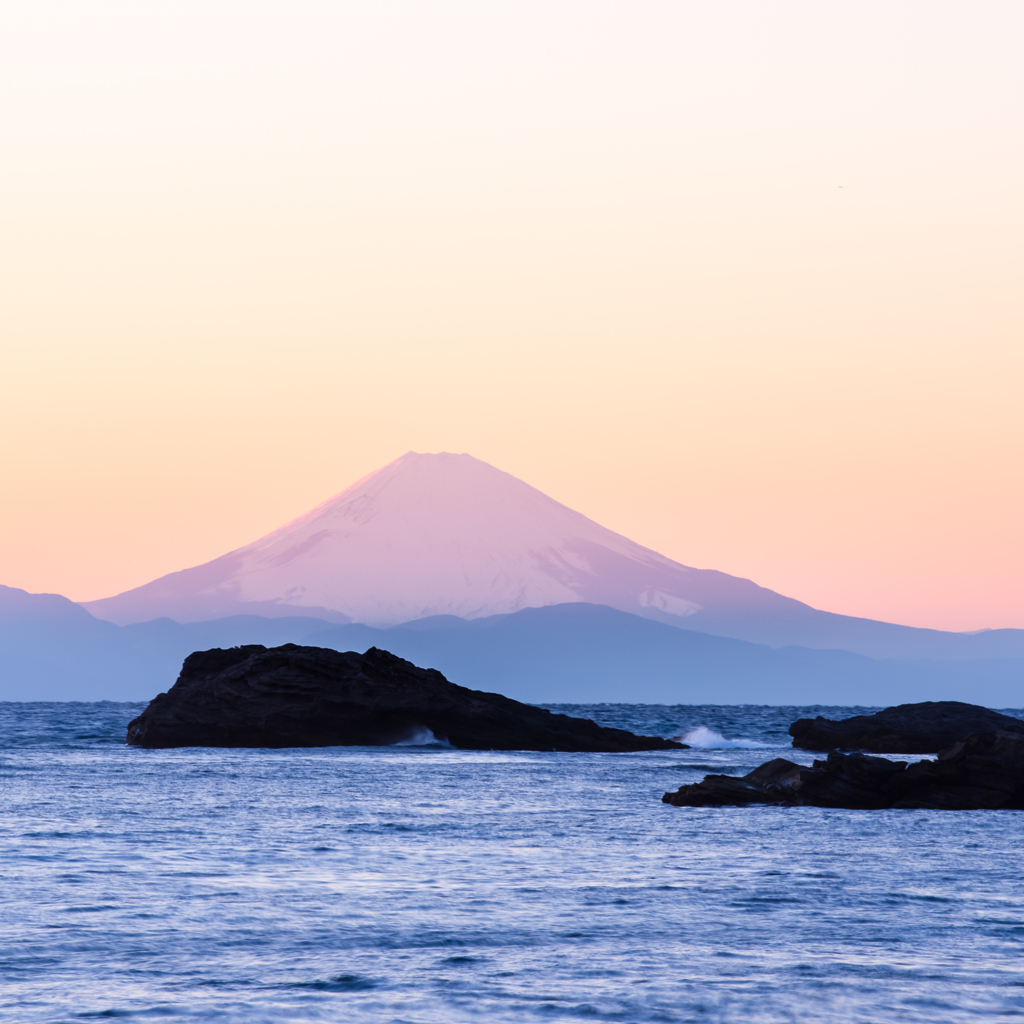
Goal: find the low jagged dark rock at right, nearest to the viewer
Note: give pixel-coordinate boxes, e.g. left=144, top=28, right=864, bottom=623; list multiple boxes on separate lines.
left=662, top=730, right=1024, bottom=811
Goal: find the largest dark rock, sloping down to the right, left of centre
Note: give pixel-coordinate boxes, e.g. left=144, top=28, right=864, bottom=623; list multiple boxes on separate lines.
left=127, top=644, right=685, bottom=752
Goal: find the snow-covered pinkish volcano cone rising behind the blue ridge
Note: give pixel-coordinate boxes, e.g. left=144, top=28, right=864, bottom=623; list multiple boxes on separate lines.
left=84, top=452, right=1024, bottom=659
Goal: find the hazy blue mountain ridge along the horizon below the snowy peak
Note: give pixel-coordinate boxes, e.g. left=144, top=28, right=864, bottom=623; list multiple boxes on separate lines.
left=0, top=587, right=1024, bottom=708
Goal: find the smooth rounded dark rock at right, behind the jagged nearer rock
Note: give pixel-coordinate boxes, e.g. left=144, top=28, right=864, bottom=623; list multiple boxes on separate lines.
left=790, top=700, right=1024, bottom=754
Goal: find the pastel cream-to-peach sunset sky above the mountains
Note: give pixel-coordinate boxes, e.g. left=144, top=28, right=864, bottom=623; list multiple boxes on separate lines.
left=0, top=0, right=1024, bottom=630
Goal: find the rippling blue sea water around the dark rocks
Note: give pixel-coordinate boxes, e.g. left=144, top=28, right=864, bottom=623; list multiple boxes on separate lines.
left=0, top=703, right=1024, bottom=1024
